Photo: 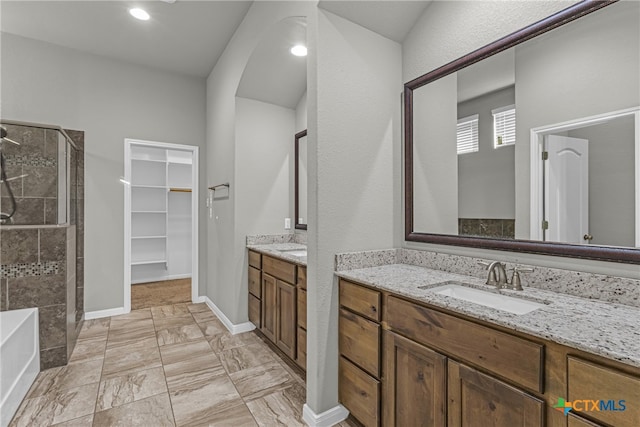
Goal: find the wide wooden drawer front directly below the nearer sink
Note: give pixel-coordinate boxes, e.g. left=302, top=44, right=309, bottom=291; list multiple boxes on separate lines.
left=386, top=296, right=544, bottom=393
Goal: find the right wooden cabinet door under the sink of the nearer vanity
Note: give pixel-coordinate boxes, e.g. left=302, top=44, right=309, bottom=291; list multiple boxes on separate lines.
left=448, top=360, right=544, bottom=427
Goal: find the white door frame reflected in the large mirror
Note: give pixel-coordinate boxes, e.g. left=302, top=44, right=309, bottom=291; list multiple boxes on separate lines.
left=529, top=106, right=640, bottom=247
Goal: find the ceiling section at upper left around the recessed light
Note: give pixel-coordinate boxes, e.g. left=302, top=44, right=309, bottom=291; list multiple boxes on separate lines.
left=0, top=0, right=252, bottom=77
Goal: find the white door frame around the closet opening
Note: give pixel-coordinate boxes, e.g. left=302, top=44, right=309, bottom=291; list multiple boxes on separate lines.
left=120, top=138, right=200, bottom=313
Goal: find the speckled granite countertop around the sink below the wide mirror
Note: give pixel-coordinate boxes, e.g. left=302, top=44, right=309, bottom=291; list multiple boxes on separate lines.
left=336, top=264, right=640, bottom=367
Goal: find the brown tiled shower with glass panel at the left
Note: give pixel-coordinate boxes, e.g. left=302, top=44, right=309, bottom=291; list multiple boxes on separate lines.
left=0, top=121, right=84, bottom=369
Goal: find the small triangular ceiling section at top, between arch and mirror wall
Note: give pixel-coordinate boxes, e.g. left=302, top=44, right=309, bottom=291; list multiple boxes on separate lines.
left=319, top=0, right=431, bottom=43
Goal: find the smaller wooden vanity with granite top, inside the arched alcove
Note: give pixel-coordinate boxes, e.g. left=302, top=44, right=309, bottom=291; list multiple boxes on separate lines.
left=248, top=243, right=307, bottom=369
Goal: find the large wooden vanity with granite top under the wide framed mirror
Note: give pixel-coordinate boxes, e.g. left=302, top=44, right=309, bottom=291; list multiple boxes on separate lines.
left=336, top=264, right=640, bottom=427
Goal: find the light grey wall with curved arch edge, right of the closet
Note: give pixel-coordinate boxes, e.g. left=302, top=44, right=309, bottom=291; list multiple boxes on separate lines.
left=206, top=2, right=314, bottom=324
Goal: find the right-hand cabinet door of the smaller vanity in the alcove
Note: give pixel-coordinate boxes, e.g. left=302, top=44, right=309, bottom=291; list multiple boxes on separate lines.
left=276, top=280, right=297, bottom=359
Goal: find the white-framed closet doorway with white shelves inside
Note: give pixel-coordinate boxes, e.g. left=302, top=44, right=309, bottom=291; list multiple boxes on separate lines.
left=123, top=139, right=198, bottom=313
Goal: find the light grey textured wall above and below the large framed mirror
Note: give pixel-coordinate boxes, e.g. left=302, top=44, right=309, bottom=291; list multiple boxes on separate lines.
left=396, top=1, right=640, bottom=278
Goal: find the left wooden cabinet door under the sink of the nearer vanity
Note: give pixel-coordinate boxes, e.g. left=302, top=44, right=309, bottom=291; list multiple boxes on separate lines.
left=382, top=331, right=447, bottom=427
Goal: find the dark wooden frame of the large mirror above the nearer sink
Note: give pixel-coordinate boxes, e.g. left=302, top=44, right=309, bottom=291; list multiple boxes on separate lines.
left=404, top=0, right=640, bottom=264
